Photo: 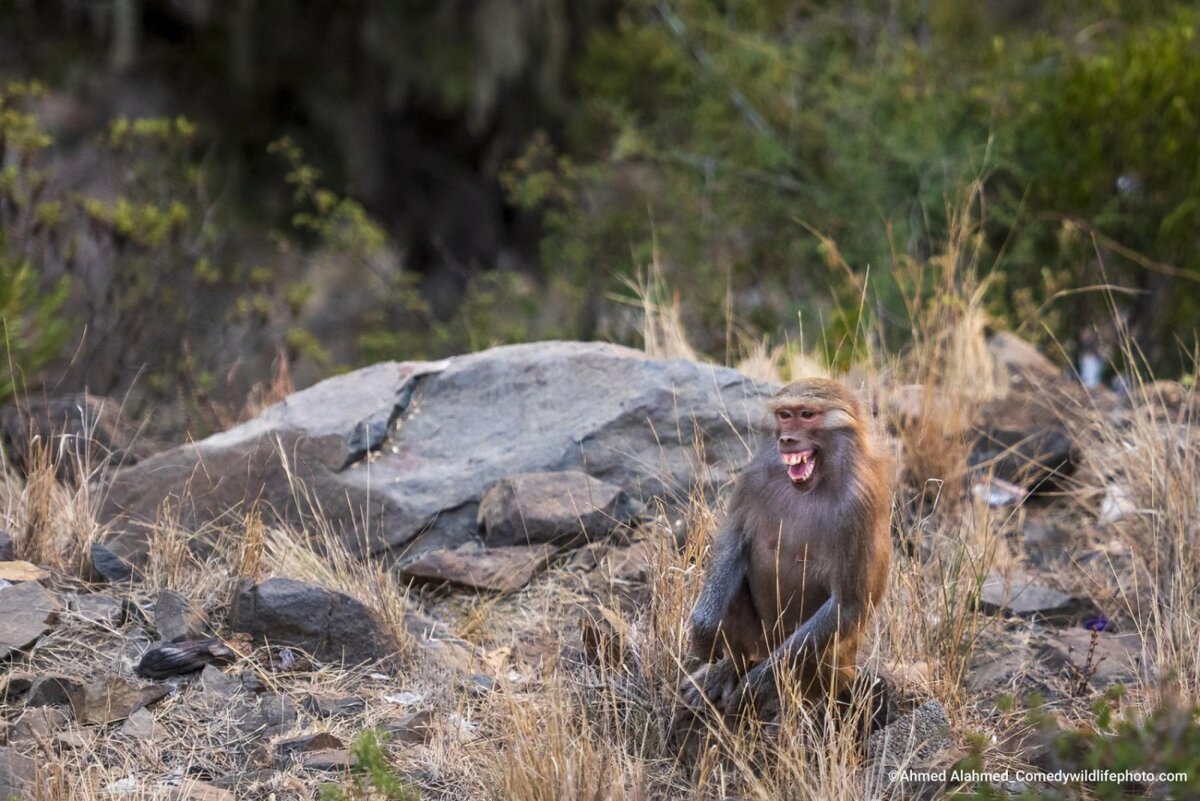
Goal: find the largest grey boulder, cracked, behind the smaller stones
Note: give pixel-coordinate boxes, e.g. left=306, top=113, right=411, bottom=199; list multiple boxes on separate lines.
left=102, top=342, right=775, bottom=572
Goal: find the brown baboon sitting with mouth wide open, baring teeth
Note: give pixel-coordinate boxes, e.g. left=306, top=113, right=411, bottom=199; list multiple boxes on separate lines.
left=682, top=379, right=892, bottom=712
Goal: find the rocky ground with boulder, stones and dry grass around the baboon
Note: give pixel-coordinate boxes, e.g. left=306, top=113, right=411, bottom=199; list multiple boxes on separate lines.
left=0, top=337, right=1200, bottom=800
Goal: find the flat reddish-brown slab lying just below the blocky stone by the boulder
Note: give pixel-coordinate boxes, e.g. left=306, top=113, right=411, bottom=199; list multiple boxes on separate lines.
left=401, top=543, right=556, bottom=592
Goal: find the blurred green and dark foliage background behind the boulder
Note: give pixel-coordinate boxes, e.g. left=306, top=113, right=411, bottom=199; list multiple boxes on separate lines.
left=0, top=0, right=1200, bottom=429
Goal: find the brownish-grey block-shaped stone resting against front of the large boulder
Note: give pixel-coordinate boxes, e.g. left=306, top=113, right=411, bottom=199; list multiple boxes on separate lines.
left=479, top=470, right=632, bottom=547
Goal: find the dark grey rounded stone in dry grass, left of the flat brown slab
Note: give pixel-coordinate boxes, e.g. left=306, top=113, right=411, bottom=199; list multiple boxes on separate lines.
left=230, top=578, right=398, bottom=663
